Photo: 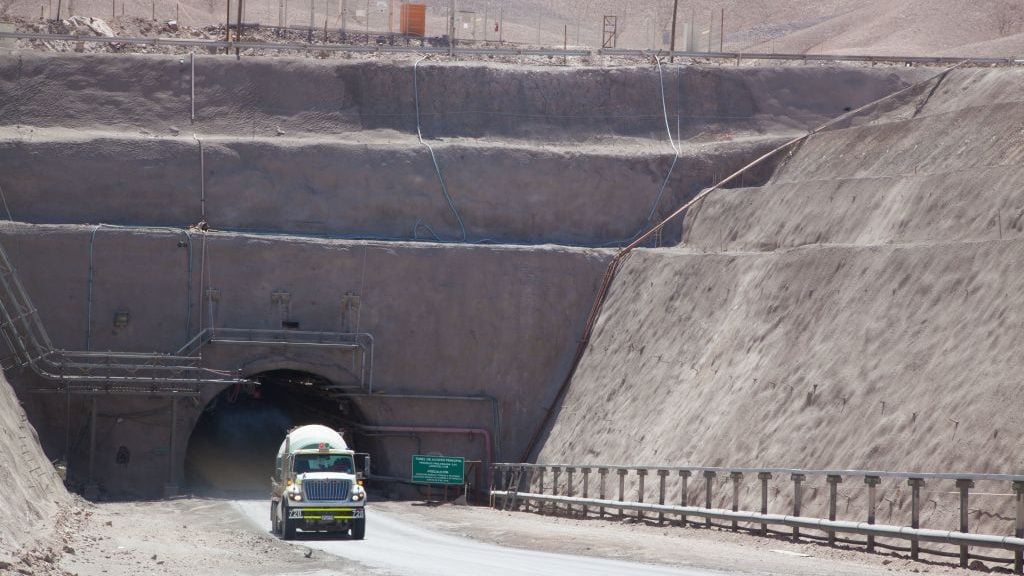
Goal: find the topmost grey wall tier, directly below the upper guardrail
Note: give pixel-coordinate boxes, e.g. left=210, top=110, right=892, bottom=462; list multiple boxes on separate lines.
left=0, top=53, right=930, bottom=141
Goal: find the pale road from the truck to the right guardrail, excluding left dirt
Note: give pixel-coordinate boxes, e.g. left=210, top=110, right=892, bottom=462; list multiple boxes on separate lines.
left=233, top=500, right=954, bottom=576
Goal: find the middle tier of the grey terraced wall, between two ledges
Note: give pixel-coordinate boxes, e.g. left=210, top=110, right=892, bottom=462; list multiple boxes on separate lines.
left=0, top=132, right=780, bottom=245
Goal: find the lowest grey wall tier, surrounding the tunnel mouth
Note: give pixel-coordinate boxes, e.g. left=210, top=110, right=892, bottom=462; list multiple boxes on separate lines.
left=3, top=225, right=608, bottom=495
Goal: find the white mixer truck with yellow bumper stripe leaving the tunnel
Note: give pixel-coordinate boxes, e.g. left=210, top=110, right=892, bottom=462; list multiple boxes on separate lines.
left=270, top=424, right=367, bottom=540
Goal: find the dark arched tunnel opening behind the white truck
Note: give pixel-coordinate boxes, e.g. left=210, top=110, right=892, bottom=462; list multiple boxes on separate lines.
left=184, top=370, right=362, bottom=497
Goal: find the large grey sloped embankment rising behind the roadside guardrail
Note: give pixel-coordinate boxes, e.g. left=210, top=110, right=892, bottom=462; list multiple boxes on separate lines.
left=540, top=70, right=1024, bottom=528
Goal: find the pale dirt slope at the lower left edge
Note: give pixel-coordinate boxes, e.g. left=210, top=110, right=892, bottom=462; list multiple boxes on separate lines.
left=0, top=368, right=70, bottom=561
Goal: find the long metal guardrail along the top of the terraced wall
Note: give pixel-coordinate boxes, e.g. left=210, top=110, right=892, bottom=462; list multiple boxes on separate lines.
left=0, top=32, right=1024, bottom=66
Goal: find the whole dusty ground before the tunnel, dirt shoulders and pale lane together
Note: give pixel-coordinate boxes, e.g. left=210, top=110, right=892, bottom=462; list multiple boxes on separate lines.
left=34, top=497, right=963, bottom=576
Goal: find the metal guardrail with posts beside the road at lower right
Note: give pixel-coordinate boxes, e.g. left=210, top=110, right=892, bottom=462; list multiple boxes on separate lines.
left=490, top=463, right=1024, bottom=574
